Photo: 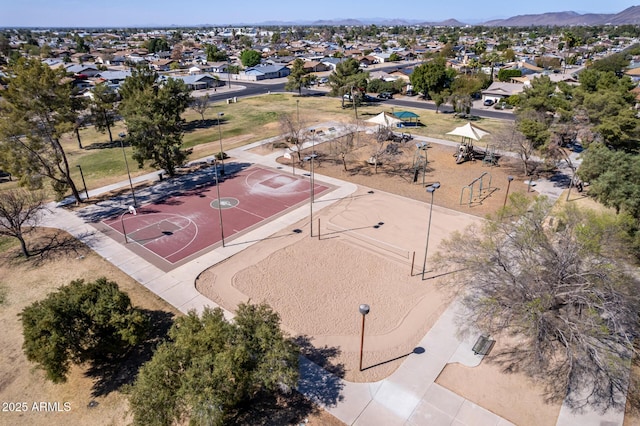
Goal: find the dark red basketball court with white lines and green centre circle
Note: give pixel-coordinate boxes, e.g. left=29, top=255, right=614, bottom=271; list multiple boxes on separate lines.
left=103, top=166, right=329, bottom=270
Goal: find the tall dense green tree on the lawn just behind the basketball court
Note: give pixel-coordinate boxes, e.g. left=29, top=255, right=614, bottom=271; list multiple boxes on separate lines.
left=120, top=68, right=191, bottom=176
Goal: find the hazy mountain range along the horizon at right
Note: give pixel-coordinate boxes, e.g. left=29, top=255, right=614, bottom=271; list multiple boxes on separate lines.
left=239, top=6, right=640, bottom=27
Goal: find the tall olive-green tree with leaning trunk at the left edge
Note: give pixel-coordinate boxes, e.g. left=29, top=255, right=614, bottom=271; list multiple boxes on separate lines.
left=0, top=58, right=82, bottom=202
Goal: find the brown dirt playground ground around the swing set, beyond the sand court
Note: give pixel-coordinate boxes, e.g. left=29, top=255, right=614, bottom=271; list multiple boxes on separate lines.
left=266, top=127, right=535, bottom=217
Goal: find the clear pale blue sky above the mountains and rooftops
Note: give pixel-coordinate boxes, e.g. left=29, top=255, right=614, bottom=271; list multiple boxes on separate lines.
left=0, top=0, right=640, bottom=28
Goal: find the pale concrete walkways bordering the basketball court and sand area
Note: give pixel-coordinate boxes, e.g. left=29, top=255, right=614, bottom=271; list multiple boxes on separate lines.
left=43, top=123, right=621, bottom=426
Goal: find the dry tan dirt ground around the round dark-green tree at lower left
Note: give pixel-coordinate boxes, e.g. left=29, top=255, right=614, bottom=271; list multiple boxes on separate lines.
left=0, top=229, right=342, bottom=426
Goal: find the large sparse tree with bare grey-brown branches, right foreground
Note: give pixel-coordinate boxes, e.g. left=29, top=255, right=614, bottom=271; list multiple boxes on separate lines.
left=438, top=193, right=640, bottom=410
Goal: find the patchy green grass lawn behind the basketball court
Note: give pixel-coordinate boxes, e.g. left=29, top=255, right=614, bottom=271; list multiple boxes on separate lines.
left=8, top=93, right=504, bottom=199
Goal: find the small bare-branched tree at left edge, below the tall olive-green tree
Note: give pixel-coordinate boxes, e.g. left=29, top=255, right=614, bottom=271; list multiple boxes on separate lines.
left=0, top=189, right=46, bottom=257
